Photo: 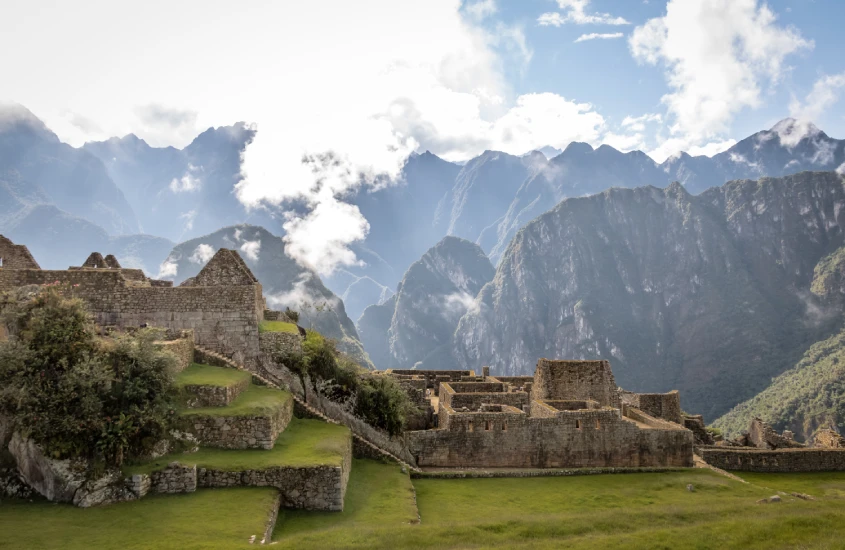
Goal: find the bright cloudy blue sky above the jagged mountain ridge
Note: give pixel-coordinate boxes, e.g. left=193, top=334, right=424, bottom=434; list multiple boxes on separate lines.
left=0, top=0, right=845, bottom=276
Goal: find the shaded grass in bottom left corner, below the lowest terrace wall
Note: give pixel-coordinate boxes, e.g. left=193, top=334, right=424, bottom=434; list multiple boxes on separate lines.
left=0, top=487, right=276, bottom=550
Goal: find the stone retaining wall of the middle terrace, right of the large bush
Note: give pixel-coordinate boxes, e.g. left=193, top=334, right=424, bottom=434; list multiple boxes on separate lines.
left=182, top=399, right=293, bottom=449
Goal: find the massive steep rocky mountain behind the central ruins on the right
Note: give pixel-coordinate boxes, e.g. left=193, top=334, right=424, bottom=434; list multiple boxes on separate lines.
left=454, top=172, right=845, bottom=418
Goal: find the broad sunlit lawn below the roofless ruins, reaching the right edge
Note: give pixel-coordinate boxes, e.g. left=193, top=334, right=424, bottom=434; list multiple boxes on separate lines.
left=274, top=470, right=845, bottom=550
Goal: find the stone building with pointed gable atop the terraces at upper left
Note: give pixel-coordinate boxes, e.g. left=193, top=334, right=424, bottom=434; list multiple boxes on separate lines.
left=0, top=235, right=264, bottom=365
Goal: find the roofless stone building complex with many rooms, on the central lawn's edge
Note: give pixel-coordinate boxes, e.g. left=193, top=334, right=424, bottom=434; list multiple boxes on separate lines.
left=400, top=359, right=693, bottom=468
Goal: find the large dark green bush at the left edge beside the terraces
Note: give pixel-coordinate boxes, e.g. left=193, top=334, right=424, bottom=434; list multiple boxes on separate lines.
left=0, top=287, right=176, bottom=466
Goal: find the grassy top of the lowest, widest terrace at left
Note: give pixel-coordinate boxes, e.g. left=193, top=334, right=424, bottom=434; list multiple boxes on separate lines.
left=124, top=418, right=351, bottom=475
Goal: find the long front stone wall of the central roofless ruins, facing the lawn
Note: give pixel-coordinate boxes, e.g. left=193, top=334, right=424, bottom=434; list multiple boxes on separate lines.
left=406, top=402, right=693, bottom=468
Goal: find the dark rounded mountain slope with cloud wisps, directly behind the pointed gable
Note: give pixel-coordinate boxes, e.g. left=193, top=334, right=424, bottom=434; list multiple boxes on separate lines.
left=159, top=224, right=372, bottom=367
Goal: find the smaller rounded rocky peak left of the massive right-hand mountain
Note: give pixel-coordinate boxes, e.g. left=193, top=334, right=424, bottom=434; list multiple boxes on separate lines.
left=358, top=237, right=494, bottom=369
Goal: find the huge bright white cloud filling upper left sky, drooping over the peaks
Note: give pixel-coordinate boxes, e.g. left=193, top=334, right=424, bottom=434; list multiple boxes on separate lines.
left=0, top=0, right=604, bottom=272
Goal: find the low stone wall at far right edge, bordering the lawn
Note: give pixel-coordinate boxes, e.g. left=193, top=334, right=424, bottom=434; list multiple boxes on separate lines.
left=699, top=447, right=845, bottom=472
